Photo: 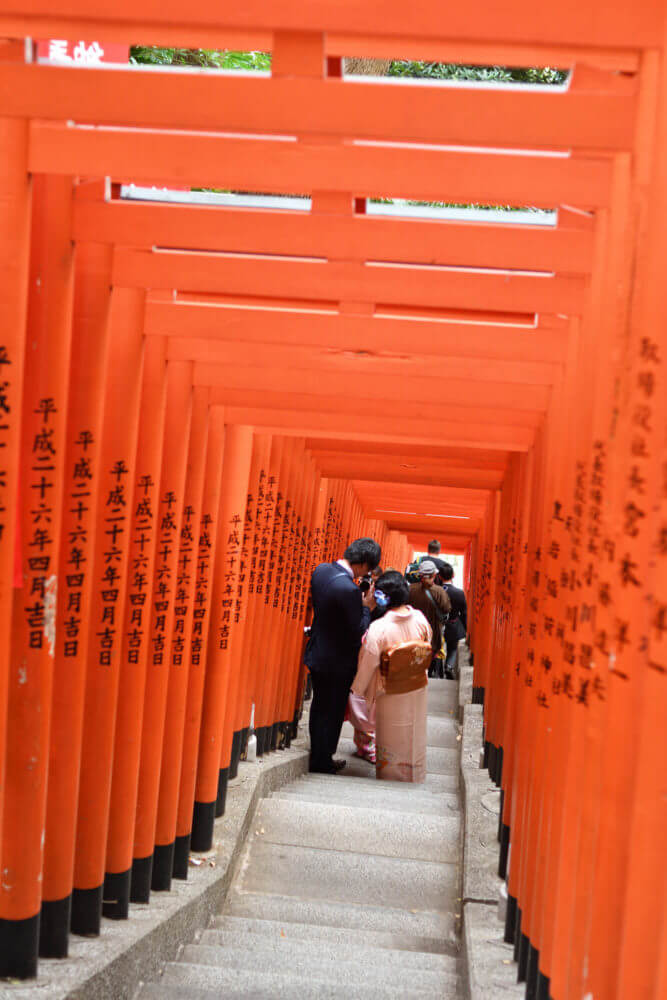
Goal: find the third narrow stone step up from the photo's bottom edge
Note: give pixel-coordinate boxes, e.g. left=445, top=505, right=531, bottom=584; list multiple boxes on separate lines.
left=197, top=928, right=456, bottom=974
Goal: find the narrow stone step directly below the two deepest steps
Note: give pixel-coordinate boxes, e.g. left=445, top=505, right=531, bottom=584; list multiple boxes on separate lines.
left=224, top=887, right=460, bottom=946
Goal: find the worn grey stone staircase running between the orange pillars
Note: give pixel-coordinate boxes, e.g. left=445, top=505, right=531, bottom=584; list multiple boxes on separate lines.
left=136, top=680, right=462, bottom=1000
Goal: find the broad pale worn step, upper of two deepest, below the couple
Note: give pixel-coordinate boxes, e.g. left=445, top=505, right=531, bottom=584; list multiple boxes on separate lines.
left=251, top=799, right=461, bottom=862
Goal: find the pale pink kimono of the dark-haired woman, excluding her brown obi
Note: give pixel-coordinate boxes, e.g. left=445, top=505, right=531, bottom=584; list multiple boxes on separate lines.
left=352, top=604, right=431, bottom=782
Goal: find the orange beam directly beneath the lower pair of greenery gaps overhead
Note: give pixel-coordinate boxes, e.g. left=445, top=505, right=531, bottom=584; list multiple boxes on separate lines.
left=73, top=200, right=593, bottom=274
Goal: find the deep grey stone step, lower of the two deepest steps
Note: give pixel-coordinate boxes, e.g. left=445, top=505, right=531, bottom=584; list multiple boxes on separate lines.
left=238, top=830, right=458, bottom=910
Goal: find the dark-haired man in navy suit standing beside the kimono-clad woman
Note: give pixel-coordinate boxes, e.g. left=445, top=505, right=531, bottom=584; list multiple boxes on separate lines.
left=305, top=538, right=382, bottom=774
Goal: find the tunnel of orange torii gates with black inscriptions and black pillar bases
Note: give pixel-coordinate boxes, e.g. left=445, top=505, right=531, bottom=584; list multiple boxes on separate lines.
left=0, top=0, right=667, bottom=1000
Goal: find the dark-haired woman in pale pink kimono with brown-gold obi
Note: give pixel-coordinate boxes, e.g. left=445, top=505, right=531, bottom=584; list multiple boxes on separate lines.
left=352, top=570, right=431, bottom=782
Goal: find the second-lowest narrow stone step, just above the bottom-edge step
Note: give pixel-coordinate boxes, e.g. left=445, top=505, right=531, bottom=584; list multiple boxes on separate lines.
left=179, top=944, right=457, bottom=990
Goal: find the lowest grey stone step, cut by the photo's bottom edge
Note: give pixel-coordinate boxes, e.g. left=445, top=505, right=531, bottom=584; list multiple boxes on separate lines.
left=155, top=962, right=458, bottom=1000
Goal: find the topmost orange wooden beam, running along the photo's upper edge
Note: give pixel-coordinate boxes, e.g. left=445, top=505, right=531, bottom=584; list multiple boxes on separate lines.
left=0, top=0, right=662, bottom=48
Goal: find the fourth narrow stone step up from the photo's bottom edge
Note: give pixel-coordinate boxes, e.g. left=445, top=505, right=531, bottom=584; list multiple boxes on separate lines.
left=211, top=915, right=458, bottom=957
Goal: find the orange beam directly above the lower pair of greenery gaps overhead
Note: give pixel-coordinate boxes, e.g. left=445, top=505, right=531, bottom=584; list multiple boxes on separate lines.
left=29, top=121, right=611, bottom=208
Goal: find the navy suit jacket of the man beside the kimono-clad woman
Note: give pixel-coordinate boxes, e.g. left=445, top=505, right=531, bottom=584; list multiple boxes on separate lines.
left=305, top=563, right=370, bottom=676
